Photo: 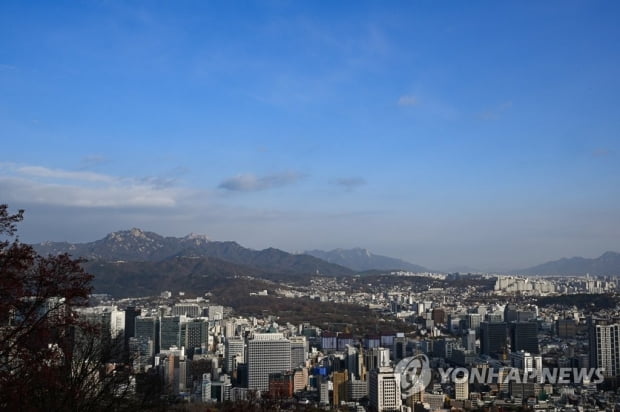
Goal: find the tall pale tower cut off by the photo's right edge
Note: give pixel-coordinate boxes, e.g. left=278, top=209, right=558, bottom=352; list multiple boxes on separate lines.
left=588, top=317, right=620, bottom=377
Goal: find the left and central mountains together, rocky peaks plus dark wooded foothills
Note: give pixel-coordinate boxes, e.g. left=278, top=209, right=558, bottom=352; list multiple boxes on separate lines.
left=33, top=228, right=438, bottom=297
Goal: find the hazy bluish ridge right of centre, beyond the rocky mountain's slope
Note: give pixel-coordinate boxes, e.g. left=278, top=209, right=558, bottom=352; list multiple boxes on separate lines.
left=304, top=248, right=430, bottom=272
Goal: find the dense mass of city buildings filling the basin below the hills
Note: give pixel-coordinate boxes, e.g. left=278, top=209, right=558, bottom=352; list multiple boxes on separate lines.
left=82, top=272, right=620, bottom=411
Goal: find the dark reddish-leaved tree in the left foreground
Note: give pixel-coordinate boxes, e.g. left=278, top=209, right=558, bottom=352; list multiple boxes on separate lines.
left=0, top=205, right=134, bottom=411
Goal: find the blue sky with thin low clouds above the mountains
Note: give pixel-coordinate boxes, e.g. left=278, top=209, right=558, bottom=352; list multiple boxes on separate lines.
left=0, top=1, right=620, bottom=270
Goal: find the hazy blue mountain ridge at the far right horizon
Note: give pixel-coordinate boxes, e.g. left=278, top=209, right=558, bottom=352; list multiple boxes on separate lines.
left=512, top=252, right=620, bottom=276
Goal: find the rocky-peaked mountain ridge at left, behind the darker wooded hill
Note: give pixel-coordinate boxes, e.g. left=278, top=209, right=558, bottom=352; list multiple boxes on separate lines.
left=33, top=228, right=354, bottom=276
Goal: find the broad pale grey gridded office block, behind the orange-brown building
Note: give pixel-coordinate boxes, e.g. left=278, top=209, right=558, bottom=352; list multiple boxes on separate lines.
left=248, top=333, right=291, bottom=392
